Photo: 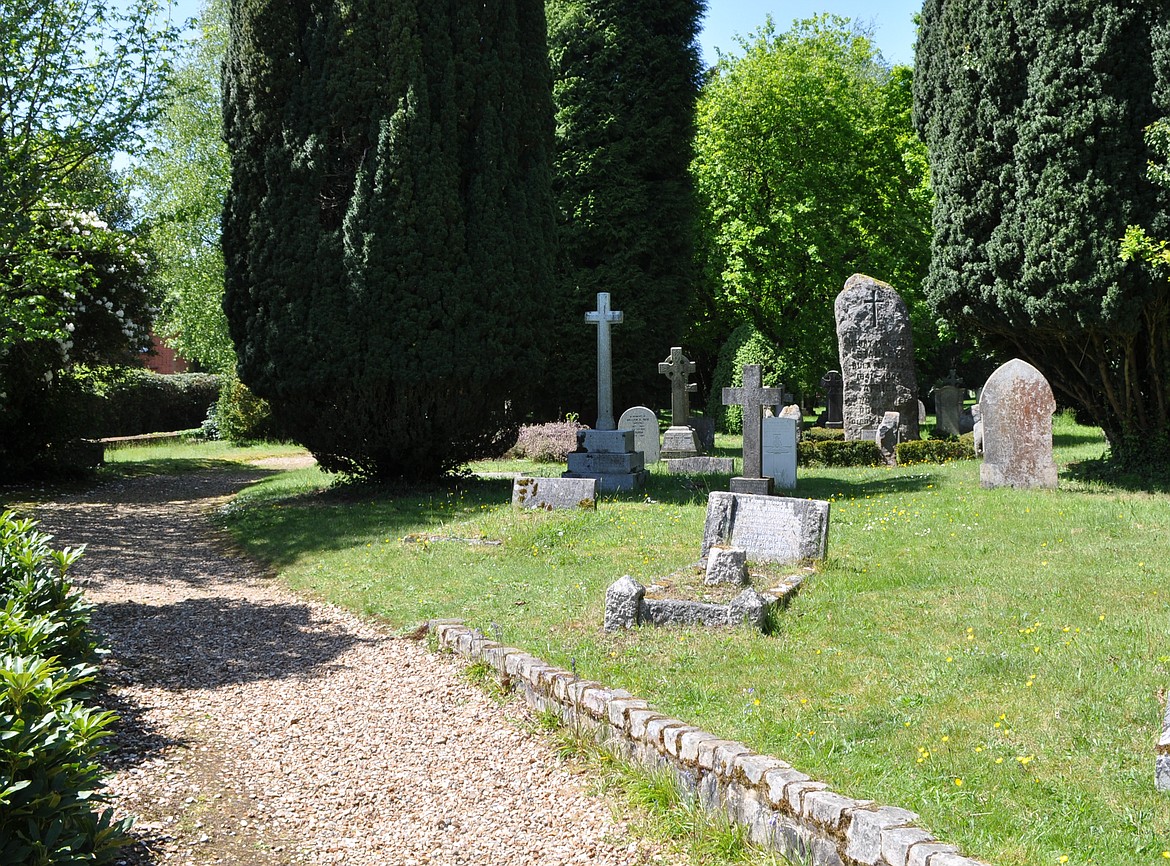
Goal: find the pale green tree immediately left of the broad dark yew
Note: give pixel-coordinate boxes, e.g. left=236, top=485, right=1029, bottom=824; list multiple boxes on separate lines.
left=131, top=0, right=235, bottom=373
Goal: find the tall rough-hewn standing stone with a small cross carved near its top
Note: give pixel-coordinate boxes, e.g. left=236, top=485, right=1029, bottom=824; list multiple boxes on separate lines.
left=834, top=274, right=918, bottom=442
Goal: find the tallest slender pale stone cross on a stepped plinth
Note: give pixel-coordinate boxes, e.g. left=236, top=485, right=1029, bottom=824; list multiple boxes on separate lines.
left=562, top=291, right=649, bottom=492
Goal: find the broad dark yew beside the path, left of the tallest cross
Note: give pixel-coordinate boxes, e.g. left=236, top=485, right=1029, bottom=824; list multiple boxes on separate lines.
left=223, top=0, right=555, bottom=479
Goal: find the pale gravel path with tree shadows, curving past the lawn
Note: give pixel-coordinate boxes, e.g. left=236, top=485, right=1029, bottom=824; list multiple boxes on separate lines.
left=37, top=469, right=666, bottom=866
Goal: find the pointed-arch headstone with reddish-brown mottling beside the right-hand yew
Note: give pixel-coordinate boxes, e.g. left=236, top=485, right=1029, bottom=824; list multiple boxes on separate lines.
left=979, top=358, right=1057, bottom=488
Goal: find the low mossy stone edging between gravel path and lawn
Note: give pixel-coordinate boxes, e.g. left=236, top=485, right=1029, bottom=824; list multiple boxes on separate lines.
left=428, top=620, right=986, bottom=866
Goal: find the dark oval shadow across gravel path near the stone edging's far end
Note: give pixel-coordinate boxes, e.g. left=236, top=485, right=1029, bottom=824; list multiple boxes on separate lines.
left=94, top=597, right=372, bottom=690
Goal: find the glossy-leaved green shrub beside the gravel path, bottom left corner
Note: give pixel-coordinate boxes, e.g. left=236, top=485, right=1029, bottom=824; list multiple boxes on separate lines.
left=0, top=513, right=128, bottom=866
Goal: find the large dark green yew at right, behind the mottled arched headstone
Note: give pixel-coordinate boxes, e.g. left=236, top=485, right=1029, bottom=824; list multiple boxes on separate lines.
left=914, top=0, right=1170, bottom=462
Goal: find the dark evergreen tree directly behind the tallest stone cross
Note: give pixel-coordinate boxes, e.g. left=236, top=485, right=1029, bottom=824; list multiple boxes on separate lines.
left=544, top=0, right=706, bottom=424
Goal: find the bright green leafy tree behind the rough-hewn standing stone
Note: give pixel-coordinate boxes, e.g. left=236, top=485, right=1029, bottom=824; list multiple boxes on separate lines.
left=691, top=16, right=937, bottom=393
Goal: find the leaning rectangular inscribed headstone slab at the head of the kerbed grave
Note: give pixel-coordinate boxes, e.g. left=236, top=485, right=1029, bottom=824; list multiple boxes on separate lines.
left=701, top=490, right=830, bottom=563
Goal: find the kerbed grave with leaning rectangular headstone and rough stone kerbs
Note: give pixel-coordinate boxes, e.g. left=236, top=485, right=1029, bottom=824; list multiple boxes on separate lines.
left=605, top=490, right=830, bottom=631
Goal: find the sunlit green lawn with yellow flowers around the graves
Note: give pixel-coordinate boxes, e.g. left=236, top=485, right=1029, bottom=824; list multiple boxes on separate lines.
left=102, top=417, right=1170, bottom=866
